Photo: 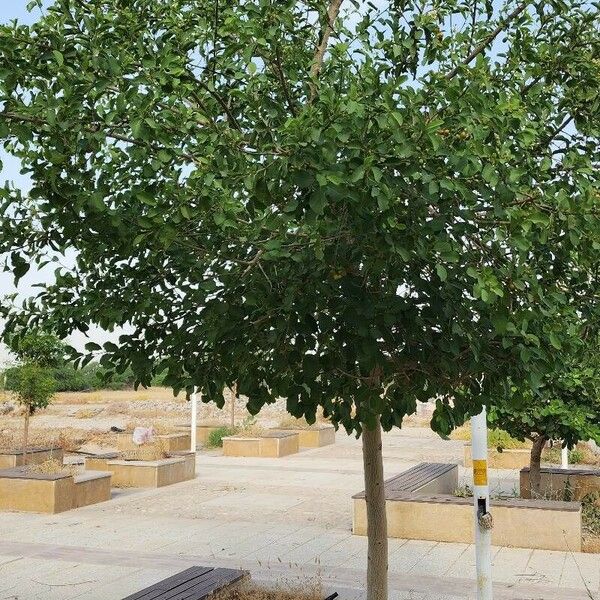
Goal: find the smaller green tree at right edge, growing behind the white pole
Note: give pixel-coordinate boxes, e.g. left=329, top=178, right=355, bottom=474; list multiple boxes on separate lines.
left=489, top=343, right=600, bottom=497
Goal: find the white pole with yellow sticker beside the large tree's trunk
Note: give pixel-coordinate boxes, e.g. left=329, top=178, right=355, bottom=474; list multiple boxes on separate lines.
left=471, top=406, right=493, bottom=600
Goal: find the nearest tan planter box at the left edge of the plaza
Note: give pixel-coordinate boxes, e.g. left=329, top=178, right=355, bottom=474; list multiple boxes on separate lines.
left=0, top=467, right=111, bottom=514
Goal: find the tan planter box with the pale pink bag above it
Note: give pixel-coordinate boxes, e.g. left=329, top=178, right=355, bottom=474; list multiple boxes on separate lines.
left=85, top=452, right=196, bottom=488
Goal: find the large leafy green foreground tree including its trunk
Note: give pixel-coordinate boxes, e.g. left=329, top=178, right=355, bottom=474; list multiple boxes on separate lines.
left=0, top=0, right=600, bottom=600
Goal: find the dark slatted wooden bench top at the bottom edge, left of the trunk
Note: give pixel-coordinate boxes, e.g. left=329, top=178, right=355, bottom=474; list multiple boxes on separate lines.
left=123, top=567, right=248, bottom=600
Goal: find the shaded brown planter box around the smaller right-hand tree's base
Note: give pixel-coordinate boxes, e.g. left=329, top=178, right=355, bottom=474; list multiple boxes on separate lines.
left=519, top=467, right=600, bottom=500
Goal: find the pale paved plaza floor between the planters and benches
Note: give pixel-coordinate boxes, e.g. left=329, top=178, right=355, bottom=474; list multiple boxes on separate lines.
left=0, top=428, right=600, bottom=600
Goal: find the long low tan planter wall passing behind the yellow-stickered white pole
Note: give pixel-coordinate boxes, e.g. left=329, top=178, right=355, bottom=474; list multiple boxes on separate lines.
left=353, top=493, right=581, bottom=552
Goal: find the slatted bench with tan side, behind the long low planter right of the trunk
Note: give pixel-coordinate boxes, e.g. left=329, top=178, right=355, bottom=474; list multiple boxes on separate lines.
left=352, top=463, right=458, bottom=500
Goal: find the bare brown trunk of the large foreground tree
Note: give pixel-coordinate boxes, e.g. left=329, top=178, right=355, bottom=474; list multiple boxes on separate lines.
left=362, top=419, right=388, bottom=600
